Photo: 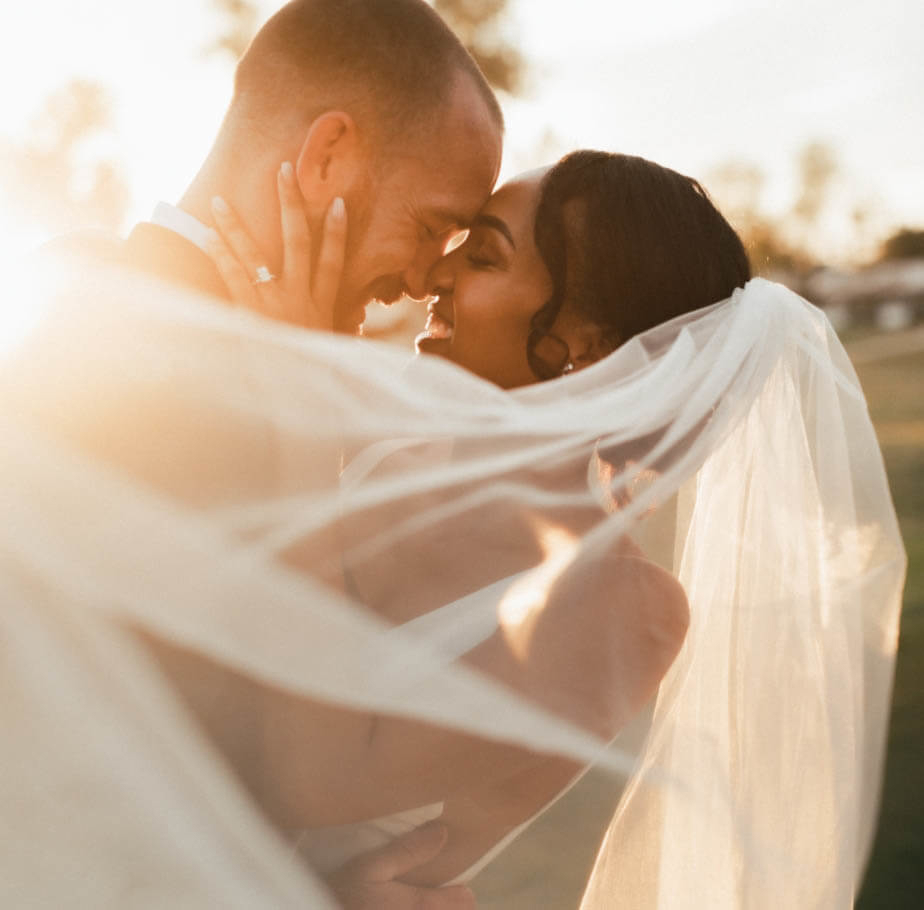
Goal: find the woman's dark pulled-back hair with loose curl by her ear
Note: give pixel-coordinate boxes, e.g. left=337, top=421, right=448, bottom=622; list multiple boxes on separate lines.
left=527, top=151, right=751, bottom=379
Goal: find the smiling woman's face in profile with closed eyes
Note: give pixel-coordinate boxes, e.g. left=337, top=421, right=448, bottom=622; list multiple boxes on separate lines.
left=417, top=171, right=553, bottom=388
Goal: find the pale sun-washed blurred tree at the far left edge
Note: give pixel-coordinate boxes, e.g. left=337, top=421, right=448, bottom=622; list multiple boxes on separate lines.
left=0, top=79, right=129, bottom=232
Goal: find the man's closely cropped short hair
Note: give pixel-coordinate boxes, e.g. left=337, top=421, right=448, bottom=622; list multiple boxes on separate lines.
left=232, top=0, right=503, bottom=143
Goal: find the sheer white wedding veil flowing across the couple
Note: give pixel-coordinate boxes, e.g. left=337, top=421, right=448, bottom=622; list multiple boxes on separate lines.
left=0, top=253, right=905, bottom=910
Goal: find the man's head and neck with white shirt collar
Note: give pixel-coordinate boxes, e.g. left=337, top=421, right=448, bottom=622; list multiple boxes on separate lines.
left=123, top=0, right=503, bottom=332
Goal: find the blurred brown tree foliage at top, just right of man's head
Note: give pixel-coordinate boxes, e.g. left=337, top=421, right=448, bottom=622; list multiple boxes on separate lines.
left=433, top=0, right=526, bottom=95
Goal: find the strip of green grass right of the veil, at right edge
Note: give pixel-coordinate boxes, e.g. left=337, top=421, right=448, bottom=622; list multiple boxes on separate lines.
left=857, top=351, right=924, bottom=910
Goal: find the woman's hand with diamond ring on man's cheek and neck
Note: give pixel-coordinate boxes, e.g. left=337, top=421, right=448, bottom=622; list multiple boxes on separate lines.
left=209, top=162, right=347, bottom=330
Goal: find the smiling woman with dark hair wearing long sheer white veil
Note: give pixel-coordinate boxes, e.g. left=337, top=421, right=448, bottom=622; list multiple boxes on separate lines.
left=3, top=153, right=903, bottom=908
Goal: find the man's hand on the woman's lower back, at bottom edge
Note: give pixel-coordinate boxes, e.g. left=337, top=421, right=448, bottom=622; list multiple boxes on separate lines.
left=328, top=822, right=475, bottom=910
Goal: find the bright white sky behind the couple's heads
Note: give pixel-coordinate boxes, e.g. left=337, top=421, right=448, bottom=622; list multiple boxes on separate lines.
left=0, top=0, right=924, bottom=264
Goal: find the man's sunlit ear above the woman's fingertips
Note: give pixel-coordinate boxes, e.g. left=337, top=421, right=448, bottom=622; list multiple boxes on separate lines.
left=295, top=111, right=365, bottom=217
